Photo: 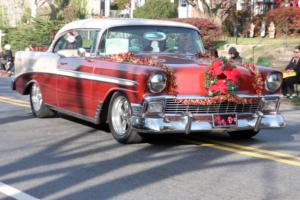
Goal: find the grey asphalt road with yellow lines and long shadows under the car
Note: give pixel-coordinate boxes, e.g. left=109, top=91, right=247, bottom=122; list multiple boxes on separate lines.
left=0, top=78, right=300, bottom=200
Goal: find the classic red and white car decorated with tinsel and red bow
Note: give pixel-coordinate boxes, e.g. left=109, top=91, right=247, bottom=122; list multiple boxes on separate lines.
left=12, top=19, right=285, bottom=143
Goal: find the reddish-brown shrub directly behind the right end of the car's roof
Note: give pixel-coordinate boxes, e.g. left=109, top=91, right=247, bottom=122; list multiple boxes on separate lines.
left=170, top=18, right=222, bottom=48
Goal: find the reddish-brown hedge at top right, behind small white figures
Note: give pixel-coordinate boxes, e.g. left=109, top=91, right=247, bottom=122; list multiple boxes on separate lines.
left=244, top=7, right=300, bottom=36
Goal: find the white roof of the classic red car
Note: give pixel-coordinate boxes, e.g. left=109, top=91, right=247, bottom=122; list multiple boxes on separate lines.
left=57, top=18, right=198, bottom=35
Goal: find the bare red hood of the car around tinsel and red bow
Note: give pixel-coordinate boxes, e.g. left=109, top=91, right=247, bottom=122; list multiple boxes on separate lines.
left=138, top=55, right=277, bottom=95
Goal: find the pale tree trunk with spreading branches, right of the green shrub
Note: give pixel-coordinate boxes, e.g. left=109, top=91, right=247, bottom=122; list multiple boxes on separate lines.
left=187, top=0, right=237, bottom=24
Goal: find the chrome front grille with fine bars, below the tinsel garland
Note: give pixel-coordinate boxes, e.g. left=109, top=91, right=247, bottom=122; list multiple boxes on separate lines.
left=165, top=99, right=261, bottom=114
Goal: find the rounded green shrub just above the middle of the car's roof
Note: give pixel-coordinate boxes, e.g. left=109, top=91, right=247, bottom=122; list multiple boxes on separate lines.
left=134, top=0, right=178, bottom=19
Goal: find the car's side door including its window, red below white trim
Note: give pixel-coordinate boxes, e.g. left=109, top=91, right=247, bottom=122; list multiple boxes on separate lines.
left=54, top=30, right=99, bottom=118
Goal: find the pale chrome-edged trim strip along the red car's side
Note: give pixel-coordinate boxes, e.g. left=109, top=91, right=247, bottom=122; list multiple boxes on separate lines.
left=15, top=69, right=138, bottom=86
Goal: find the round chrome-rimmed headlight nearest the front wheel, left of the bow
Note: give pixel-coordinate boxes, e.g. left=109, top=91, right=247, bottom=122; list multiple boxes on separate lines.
left=148, top=73, right=167, bottom=93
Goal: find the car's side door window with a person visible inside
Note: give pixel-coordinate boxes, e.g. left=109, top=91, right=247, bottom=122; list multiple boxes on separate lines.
left=53, top=30, right=99, bottom=57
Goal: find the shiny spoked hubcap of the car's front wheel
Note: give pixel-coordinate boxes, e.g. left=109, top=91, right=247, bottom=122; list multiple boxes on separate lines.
left=111, top=96, right=131, bottom=136
